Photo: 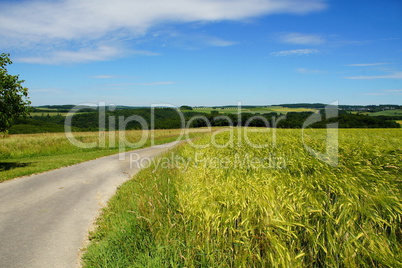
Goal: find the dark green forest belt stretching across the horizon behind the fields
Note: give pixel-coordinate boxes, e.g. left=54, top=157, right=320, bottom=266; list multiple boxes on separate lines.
left=9, top=104, right=402, bottom=134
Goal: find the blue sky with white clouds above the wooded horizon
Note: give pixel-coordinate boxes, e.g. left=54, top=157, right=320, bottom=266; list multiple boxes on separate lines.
left=0, top=0, right=402, bottom=106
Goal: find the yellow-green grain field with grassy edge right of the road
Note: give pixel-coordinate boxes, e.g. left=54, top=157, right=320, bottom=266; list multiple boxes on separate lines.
left=83, top=129, right=402, bottom=267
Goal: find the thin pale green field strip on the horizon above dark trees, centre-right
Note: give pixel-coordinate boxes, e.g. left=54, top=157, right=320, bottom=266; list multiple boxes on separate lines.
left=194, top=106, right=316, bottom=114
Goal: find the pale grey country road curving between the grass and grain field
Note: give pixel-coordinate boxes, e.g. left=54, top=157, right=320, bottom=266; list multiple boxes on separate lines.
left=0, top=142, right=177, bottom=268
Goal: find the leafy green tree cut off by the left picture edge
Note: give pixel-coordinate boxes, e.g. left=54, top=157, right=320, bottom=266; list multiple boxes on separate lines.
left=0, top=53, right=31, bottom=132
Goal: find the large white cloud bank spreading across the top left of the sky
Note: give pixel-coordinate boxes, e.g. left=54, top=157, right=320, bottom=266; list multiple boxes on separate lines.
left=0, top=0, right=327, bottom=64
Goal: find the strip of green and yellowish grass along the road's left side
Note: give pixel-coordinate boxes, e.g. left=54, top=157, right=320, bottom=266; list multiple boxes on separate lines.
left=0, top=129, right=212, bottom=182
